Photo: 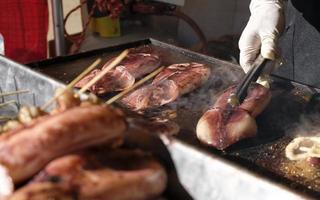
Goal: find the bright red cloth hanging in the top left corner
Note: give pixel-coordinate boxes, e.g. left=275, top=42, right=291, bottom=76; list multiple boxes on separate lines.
left=0, top=0, right=49, bottom=63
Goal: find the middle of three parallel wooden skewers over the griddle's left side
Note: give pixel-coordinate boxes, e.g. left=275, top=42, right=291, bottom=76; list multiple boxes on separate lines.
left=78, top=49, right=129, bottom=94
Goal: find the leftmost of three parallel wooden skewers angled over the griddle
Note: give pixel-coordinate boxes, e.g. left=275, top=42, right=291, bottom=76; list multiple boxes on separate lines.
left=41, top=58, right=101, bottom=110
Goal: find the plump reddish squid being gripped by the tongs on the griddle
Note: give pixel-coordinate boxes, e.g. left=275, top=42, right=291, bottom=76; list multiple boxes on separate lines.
left=196, top=83, right=271, bottom=150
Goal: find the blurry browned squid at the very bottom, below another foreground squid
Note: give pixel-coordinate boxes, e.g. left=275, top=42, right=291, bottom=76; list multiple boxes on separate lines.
left=9, top=149, right=167, bottom=200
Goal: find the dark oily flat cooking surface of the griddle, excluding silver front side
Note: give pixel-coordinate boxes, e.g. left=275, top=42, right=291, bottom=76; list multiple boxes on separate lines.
left=29, top=39, right=320, bottom=197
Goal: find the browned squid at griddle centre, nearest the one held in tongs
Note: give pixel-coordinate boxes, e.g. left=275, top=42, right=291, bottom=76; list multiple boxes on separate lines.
left=121, top=63, right=211, bottom=110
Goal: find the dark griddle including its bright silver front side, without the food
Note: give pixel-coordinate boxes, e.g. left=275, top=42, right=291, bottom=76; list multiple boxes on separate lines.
left=28, top=39, right=320, bottom=199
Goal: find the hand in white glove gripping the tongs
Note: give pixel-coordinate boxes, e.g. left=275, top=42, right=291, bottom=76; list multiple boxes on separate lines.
left=239, top=0, right=285, bottom=73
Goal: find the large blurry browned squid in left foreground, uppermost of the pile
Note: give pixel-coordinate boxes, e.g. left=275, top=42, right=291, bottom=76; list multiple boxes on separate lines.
left=0, top=106, right=126, bottom=184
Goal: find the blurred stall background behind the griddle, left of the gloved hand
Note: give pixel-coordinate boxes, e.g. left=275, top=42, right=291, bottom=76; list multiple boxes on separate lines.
left=0, top=0, right=250, bottom=63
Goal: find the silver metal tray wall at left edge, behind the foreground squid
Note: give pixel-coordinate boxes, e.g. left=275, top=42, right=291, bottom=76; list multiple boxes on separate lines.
left=0, top=55, right=63, bottom=117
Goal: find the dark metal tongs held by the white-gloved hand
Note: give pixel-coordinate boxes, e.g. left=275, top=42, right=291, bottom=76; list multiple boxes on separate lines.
left=228, top=54, right=271, bottom=108
